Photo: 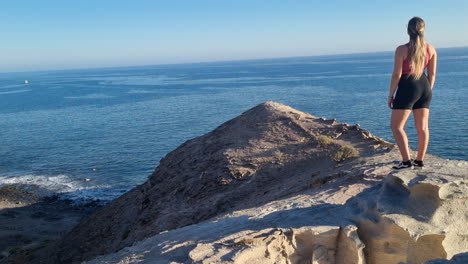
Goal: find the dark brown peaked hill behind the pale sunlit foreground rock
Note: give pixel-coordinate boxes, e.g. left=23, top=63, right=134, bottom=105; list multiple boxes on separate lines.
left=42, top=102, right=391, bottom=263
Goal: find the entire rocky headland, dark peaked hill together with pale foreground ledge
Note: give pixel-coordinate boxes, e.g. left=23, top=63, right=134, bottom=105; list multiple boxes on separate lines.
left=23, top=102, right=468, bottom=264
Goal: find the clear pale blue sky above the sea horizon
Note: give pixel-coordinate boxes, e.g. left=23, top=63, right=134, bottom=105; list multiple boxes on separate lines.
left=0, top=0, right=468, bottom=72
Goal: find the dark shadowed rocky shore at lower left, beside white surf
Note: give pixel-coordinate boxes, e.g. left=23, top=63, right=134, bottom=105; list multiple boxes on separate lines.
left=0, top=184, right=102, bottom=263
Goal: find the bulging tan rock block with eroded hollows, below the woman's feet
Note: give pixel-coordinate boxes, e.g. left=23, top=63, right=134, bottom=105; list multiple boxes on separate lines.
left=347, top=162, right=468, bottom=263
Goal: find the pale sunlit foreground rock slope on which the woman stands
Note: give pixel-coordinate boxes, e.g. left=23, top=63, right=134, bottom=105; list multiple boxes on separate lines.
left=86, top=151, right=468, bottom=264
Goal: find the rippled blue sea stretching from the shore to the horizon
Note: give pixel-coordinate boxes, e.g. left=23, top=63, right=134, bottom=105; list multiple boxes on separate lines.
left=0, top=48, right=468, bottom=200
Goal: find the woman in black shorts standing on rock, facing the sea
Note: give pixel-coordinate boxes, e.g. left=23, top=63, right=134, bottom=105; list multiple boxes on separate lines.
left=388, top=17, right=437, bottom=169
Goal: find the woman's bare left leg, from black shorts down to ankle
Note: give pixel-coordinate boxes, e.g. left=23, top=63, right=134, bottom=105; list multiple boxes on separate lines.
left=390, top=109, right=411, bottom=161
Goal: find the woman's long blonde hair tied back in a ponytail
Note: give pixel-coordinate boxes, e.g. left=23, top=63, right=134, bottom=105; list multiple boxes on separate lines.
left=408, top=17, right=426, bottom=79
